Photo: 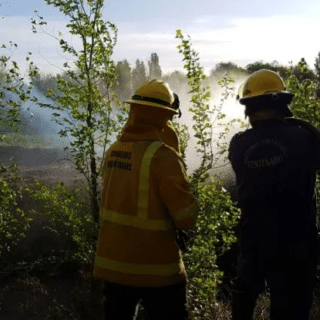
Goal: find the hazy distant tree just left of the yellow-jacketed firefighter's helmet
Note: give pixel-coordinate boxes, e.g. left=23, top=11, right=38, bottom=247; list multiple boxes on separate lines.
left=114, top=59, right=133, bottom=101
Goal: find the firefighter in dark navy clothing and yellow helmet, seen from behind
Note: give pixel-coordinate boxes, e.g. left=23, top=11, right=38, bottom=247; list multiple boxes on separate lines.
left=229, top=69, right=320, bottom=320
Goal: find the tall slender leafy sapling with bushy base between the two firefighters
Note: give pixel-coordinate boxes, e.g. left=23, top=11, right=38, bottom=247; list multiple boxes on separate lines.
left=176, top=30, right=240, bottom=319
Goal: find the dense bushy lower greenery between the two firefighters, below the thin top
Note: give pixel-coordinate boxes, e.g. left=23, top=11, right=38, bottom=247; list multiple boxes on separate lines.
left=184, top=178, right=240, bottom=319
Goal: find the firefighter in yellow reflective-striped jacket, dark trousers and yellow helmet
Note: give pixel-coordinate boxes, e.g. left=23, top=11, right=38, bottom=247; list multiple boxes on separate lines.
left=94, top=80, right=198, bottom=320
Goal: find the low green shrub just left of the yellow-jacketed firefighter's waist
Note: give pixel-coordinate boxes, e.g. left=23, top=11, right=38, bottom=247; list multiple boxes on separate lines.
left=27, top=181, right=98, bottom=265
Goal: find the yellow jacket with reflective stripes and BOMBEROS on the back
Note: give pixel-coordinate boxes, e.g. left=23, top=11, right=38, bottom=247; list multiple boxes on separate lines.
left=94, top=116, right=198, bottom=286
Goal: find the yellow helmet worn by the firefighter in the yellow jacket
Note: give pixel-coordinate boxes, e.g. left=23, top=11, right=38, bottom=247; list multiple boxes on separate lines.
left=125, top=79, right=180, bottom=114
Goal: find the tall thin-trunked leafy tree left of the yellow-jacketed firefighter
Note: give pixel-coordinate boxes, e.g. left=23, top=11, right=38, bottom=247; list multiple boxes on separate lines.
left=32, top=0, right=124, bottom=223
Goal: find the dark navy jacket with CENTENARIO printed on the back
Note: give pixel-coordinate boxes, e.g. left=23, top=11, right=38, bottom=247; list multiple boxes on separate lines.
left=229, top=120, right=320, bottom=254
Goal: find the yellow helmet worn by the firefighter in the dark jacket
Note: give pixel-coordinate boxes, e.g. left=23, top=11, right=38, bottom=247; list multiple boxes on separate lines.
left=239, top=69, right=293, bottom=104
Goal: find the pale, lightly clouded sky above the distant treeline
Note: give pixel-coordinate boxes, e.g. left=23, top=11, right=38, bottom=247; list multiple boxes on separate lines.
left=0, top=0, right=320, bottom=72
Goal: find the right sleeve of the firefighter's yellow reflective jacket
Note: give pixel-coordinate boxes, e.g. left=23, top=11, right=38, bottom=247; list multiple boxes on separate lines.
left=159, top=147, right=199, bottom=230
